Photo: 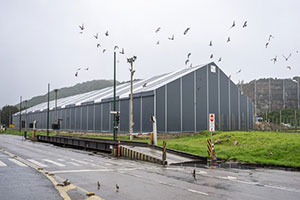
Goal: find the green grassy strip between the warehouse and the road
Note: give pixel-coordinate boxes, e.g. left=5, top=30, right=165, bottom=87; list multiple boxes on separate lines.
left=1, top=130, right=300, bottom=167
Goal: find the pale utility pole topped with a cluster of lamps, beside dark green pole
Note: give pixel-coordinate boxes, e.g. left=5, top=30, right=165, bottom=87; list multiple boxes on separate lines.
left=127, top=56, right=136, bottom=140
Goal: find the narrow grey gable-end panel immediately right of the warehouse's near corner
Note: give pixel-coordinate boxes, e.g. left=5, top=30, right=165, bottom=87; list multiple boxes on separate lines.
left=156, top=87, right=165, bottom=132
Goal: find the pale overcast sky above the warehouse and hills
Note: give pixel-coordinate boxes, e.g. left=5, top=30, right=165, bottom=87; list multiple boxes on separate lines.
left=0, top=0, right=300, bottom=107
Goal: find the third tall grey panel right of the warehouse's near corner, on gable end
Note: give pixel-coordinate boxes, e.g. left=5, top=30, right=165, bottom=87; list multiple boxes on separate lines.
left=182, top=73, right=195, bottom=131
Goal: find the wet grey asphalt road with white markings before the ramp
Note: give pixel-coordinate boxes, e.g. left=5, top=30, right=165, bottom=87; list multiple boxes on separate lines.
left=0, top=135, right=300, bottom=200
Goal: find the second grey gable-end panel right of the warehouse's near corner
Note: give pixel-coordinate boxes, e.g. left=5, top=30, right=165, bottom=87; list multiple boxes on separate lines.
left=167, top=79, right=181, bottom=132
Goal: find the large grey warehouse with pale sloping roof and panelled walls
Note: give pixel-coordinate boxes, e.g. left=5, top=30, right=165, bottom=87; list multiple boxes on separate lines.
left=13, top=63, right=253, bottom=132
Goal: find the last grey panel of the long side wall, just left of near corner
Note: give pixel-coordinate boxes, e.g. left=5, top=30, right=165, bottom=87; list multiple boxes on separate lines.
left=142, top=96, right=154, bottom=132
